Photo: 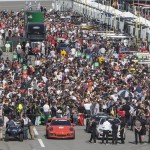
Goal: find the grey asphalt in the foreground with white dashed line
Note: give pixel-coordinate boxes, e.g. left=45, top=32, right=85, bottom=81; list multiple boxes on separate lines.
left=0, top=126, right=150, bottom=150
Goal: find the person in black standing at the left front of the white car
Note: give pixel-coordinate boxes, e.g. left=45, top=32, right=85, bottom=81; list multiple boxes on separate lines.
left=89, top=118, right=96, bottom=143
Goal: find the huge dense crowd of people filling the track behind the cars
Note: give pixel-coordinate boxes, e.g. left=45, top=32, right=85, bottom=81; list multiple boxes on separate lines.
left=0, top=5, right=150, bottom=143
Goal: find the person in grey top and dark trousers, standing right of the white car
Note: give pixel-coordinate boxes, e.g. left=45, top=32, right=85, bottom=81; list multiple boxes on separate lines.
left=134, top=116, right=142, bottom=144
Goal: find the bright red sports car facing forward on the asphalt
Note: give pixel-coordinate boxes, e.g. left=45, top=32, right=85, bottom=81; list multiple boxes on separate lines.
left=46, top=118, right=75, bottom=139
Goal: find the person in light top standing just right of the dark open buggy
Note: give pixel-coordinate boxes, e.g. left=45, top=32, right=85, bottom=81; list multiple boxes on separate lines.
left=22, top=114, right=30, bottom=140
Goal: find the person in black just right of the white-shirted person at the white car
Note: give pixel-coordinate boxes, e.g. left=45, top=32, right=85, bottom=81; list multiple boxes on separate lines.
left=112, top=121, right=118, bottom=144
